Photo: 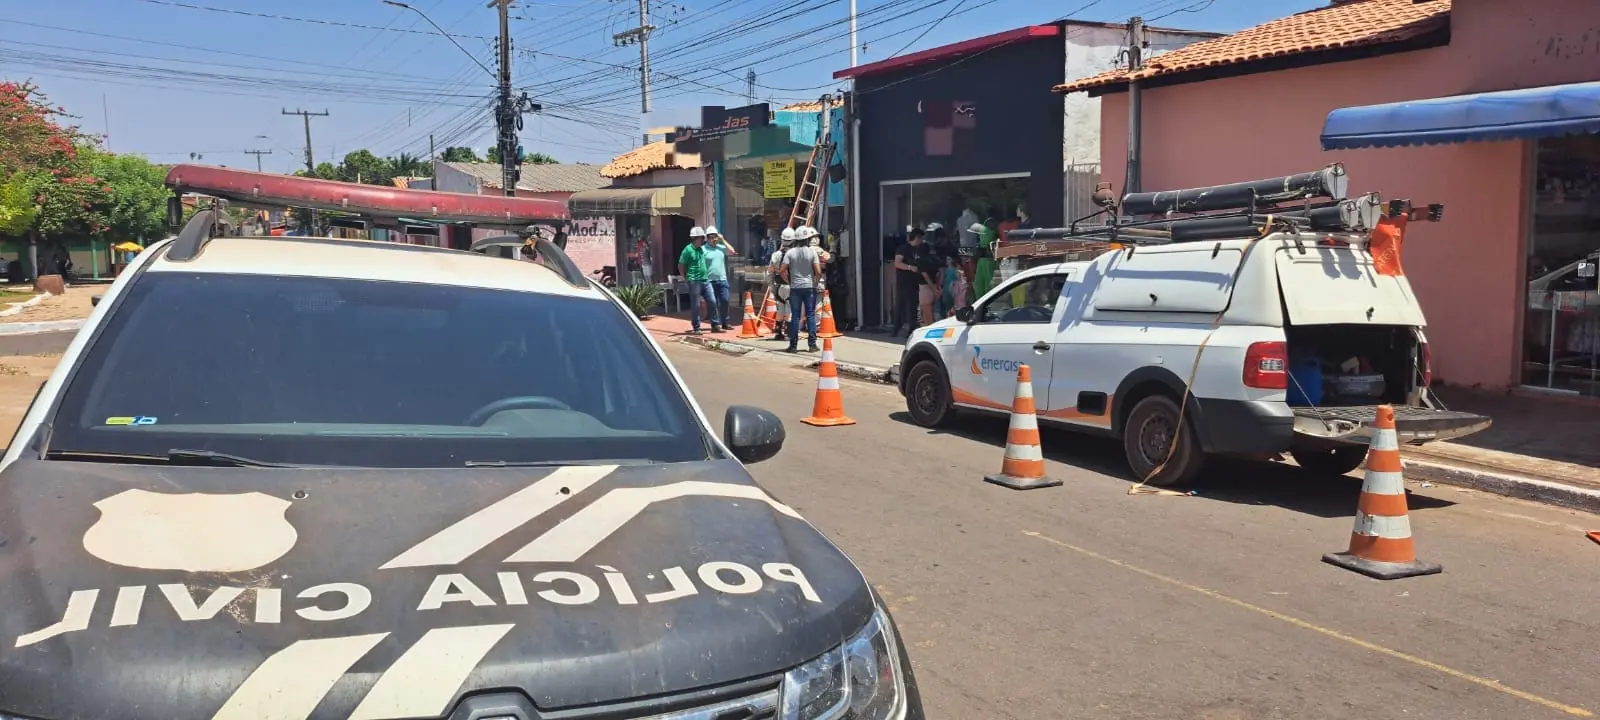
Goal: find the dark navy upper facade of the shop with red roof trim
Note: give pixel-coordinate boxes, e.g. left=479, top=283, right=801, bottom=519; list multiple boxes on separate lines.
left=835, top=24, right=1066, bottom=325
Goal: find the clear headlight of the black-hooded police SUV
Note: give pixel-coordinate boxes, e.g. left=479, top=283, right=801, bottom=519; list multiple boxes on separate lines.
left=779, top=610, right=906, bottom=720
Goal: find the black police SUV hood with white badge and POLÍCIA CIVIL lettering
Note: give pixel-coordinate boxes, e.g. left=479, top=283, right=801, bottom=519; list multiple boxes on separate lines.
left=0, top=461, right=874, bottom=720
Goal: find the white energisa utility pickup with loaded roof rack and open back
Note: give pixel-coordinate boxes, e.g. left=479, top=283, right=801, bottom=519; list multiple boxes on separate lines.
left=899, top=165, right=1490, bottom=486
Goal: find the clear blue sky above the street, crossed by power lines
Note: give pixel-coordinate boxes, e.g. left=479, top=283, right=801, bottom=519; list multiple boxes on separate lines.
left=0, top=0, right=1326, bottom=171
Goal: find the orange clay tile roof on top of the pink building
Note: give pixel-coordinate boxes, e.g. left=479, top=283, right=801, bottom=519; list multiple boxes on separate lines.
left=1054, top=0, right=1451, bottom=93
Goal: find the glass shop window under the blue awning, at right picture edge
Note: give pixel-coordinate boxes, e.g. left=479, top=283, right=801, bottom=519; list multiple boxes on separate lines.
left=1523, top=134, right=1600, bottom=395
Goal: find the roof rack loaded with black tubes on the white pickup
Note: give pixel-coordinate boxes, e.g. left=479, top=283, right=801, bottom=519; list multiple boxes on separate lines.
left=997, top=163, right=1445, bottom=256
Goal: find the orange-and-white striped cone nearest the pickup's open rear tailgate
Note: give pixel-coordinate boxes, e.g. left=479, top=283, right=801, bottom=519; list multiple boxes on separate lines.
left=1322, top=405, right=1445, bottom=579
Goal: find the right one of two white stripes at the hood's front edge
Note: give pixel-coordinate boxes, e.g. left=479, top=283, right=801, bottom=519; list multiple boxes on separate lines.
left=349, top=624, right=514, bottom=720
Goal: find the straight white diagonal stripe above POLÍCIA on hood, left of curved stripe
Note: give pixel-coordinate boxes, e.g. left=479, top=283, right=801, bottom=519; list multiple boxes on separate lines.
left=381, top=466, right=616, bottom=570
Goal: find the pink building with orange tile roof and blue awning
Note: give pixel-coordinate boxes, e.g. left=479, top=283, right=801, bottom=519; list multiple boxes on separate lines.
left=1056, top=0, right=1600, bottom=397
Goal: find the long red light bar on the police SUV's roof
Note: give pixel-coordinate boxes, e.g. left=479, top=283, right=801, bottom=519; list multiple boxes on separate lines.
left=166, top=165, right=568, bottom=226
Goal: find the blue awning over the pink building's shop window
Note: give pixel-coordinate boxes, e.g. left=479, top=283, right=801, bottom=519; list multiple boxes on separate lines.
left=1322, top=82, right=1600, bottom=150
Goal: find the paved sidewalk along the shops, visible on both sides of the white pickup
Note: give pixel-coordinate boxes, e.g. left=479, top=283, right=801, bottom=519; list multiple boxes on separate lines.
left=645, top=315, right=1600, bottom=514
